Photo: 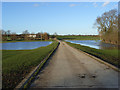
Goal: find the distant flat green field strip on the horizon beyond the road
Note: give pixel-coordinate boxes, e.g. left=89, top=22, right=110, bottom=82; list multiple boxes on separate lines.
left=57, top=36, right=100, bottom=40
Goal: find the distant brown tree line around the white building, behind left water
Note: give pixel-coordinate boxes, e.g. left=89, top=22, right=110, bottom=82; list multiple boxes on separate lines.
left=0, top=30, right=50, bottom=41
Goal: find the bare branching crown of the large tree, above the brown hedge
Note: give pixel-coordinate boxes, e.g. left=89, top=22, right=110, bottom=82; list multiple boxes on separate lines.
left=94, top=9, right=118, bottom=34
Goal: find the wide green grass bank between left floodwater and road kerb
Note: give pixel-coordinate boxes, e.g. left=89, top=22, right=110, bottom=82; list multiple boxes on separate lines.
left=2, top=41, right=58, bottom=88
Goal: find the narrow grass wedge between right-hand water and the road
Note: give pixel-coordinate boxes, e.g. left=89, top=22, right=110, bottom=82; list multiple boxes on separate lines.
left=66, top=42, right=120, bottom=67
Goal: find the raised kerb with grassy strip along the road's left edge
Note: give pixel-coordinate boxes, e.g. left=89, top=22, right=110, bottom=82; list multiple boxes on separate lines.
left=14, top=42, right=60, bottom=90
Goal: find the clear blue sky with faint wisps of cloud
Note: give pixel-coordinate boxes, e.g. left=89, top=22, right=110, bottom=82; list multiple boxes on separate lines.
left=2, top=2, right=118, bottom=35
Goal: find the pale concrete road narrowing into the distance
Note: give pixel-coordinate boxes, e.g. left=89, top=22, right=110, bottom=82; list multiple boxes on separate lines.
left=30, top=42, right=118, bottom=88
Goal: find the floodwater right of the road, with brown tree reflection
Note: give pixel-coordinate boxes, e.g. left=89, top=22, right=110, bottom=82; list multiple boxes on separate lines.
left=66, top=40, right=117, bottom=49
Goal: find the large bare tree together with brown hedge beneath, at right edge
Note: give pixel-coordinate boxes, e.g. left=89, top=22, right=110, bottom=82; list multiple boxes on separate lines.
left=94, top=9, right=120, bottom=45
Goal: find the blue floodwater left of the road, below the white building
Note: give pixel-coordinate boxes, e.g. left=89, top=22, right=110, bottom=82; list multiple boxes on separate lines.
left=0, top=41, right=52, bottom=50
